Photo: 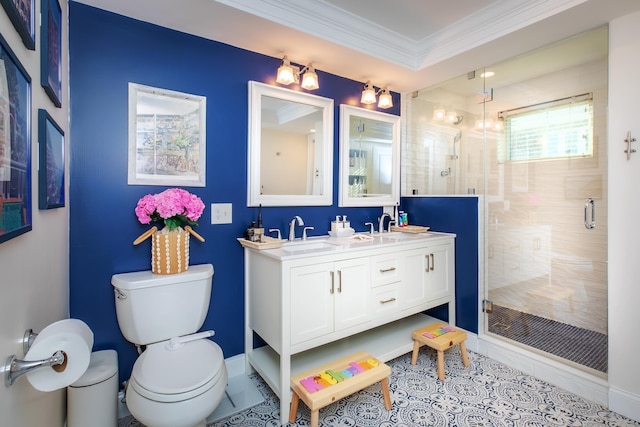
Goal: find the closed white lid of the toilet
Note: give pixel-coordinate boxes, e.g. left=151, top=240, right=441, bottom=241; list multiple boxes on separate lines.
left=131, top=339, right=224, bottom=394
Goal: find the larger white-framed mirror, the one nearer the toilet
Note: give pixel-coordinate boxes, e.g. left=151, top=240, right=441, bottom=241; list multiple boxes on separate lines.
left=247, top=81, right=333, bottom=206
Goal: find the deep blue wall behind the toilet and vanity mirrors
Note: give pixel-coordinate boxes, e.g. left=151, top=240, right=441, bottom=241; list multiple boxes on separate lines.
left=69, top=2, right=477, bottom=379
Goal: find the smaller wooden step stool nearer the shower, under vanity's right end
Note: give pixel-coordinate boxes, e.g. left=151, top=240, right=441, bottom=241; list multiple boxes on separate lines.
left=411, top=322, right=469, bottom=380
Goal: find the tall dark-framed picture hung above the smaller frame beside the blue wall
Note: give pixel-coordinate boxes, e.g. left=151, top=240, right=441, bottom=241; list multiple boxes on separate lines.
left=40, top=0, right=62, bottom=107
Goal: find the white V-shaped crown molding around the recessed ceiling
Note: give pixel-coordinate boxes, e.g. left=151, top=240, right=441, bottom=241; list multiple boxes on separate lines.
left=216, top=0, right=588, bottom=71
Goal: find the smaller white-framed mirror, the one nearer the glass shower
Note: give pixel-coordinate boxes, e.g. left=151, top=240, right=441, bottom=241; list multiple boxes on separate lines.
left=339, top=105, right=400, bottom=206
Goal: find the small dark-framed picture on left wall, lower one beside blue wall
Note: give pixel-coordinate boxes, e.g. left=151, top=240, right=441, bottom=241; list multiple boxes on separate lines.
left=38, top=109, right=65, bottom=209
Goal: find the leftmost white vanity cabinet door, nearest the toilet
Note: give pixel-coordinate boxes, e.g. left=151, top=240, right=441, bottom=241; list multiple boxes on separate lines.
left=290, top=262, right=335, bottom=345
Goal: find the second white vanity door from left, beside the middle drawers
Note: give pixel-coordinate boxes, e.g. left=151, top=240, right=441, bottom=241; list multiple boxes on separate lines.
left=334, top=257, right=371, bottom=331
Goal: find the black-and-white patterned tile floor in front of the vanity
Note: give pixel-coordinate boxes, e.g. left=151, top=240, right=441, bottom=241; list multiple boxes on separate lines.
left=119, top=347, right=640, bottom=427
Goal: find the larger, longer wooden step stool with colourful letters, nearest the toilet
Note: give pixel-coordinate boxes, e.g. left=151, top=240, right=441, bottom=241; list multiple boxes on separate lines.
left=289, top=351, right=391, bottom=427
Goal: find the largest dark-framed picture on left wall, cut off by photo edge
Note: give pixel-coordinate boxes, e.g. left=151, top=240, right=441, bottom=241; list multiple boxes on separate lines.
left=0, top=35, right=32, bottom=243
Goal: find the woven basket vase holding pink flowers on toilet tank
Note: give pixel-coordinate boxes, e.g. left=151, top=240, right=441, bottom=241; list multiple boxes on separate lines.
left=151, top=228, right=189, bottom=274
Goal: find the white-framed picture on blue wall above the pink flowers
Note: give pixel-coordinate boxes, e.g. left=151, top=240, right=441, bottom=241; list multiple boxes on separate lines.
left=128, top=83, right=206, bottom=187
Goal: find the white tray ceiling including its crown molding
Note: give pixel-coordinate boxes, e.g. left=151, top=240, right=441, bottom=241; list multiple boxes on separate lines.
left=76, top=0, right=640, bottom=92
